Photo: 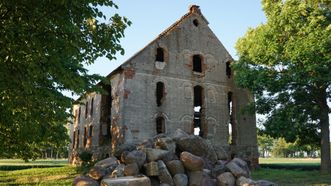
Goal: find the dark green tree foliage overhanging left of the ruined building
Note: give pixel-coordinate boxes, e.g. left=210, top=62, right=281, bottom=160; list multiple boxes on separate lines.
left=0, top=0, right=130, bottom=159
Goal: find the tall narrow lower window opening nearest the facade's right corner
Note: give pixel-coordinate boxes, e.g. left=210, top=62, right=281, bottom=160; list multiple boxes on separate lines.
left=228, top=92, right=237, bottom=145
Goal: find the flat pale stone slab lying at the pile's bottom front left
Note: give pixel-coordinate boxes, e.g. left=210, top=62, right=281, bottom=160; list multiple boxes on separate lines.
left=100, top=175, right=151, bottom=186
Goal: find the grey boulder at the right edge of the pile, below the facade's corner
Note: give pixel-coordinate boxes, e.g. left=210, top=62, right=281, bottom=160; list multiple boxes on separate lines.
left=225, top=158, right=250, bottom=178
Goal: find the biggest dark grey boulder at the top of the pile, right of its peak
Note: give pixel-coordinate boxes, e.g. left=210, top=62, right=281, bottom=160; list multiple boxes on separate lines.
left=176, top=135, right=217, bottom=163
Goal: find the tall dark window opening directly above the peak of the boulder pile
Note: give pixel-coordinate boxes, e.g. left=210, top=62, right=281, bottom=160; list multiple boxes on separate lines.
left=193, top=85, right=204, bottom=137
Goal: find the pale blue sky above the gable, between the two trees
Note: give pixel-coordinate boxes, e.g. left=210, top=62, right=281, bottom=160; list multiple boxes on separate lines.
left=87, top=0, right=266, bottom=75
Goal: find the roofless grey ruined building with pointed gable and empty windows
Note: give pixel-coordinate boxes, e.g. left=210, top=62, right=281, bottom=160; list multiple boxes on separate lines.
left=70, top=5, right=258, bottom=164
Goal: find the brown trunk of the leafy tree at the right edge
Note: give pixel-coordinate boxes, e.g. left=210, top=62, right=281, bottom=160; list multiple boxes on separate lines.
left=320, top=92, right=331, bottom=173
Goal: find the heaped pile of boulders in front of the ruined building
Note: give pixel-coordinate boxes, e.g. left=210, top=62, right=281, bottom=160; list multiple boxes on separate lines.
left=73, top=129, right=276, bottom=186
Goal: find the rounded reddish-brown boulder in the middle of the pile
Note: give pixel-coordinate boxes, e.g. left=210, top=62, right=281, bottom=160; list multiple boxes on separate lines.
left=180, top=152, right=204, bottom=171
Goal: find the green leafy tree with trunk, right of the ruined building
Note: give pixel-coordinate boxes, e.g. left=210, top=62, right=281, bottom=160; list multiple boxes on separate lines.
left=234, top=0, right=331, bottom=172
